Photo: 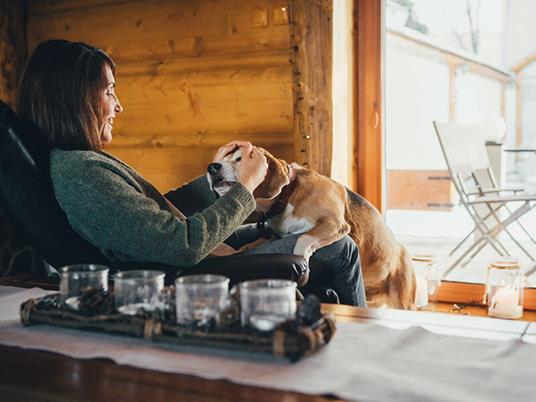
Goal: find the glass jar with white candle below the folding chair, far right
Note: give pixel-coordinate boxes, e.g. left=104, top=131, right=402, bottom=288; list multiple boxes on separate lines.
left=485, top=256, right=525, bottom=319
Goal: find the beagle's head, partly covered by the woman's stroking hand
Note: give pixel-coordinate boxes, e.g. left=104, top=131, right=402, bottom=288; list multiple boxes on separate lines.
left=207, top=147, right=290, bottom=199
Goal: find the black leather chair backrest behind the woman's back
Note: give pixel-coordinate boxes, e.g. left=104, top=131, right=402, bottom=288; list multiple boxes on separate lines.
left=0, top=101, right=108, bottom=267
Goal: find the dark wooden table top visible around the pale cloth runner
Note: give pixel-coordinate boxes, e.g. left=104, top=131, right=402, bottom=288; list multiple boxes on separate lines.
left=0, top=279, right=534, bottom=402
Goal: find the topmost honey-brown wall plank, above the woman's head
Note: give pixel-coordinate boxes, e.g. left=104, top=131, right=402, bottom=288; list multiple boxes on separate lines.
left=28, top=0, right=289, bottom=61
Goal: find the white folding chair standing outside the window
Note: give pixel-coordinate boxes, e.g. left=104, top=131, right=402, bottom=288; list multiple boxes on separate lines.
left=434, top=121, right=536, bottom=275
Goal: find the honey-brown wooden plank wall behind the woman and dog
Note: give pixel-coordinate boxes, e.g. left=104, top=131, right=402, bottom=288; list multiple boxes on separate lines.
left=27, top=0, right=295, bottom=191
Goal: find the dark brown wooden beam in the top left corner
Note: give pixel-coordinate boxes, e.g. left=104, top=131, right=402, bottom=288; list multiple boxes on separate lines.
left=0, top=0, right=26, bottom=108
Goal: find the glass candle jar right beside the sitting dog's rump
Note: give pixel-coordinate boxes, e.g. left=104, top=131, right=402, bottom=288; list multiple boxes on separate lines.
left=411, top=254, right=441, bottom=307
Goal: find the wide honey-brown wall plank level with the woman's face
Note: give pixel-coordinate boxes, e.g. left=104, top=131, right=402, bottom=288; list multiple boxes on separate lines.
left=110, top=66, right=293, bottom=137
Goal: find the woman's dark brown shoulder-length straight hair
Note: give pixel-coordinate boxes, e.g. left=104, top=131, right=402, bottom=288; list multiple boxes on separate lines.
left=17, top=40, right=115, bottom=151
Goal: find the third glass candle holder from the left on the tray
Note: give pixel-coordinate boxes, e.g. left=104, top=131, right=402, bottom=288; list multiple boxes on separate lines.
left=175, top=274, right=229, bottom=326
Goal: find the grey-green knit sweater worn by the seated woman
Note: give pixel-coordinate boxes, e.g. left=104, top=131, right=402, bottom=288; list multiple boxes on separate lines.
left=50, top=149, right=255, bottom=267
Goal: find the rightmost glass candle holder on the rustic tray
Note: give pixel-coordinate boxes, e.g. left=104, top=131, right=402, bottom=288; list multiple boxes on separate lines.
left=238, top=279, right=296, bottom=331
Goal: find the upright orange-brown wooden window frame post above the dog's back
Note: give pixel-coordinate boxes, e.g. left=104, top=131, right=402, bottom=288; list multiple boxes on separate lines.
left=354, top=0, right=383, bottom=211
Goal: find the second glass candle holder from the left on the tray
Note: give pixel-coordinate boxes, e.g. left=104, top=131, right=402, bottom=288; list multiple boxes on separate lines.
left=114, top=270, right=164, bottom=315
